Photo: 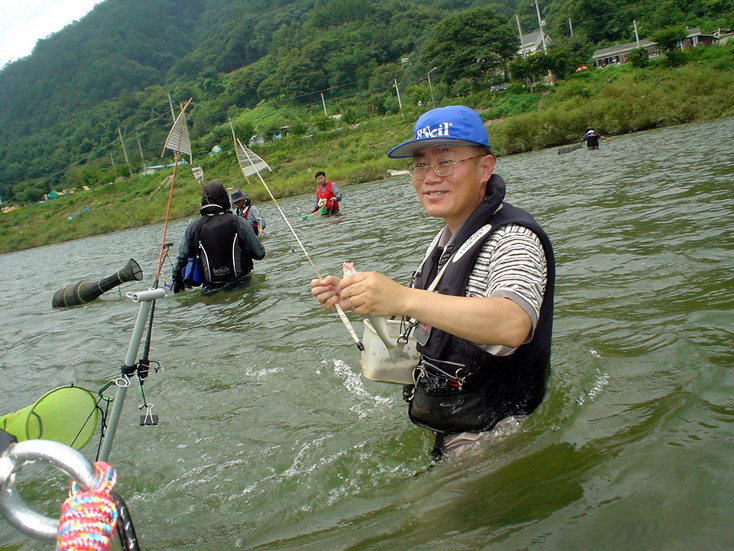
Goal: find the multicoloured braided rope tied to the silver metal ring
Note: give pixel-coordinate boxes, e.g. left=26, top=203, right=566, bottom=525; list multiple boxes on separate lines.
left=57, top=461, right=118, bottom=551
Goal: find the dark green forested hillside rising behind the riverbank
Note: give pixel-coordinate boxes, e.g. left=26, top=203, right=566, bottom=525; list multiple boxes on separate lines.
left=0, top=0, right=732, bottom=201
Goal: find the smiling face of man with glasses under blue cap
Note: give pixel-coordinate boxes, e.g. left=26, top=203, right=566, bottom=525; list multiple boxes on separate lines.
left=413, top=145, right=494, bottom=232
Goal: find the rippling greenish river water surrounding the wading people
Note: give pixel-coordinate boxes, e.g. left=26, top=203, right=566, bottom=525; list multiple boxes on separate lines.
left=0, top=119, right=734, bottom=550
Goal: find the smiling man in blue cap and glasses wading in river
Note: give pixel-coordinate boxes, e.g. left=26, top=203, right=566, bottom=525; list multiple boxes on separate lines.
left=311, top=105, right=555, bottom=457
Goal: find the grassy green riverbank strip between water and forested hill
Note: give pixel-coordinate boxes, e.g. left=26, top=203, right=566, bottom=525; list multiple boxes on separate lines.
left=0, top=44, right=734, bottom=253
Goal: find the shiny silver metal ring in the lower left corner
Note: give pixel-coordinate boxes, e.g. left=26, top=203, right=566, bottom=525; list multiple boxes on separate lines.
left=0, top=440, right=96, bottom=540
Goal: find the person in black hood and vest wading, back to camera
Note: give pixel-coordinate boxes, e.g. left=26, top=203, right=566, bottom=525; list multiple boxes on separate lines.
left=173, top=181, right=265, bottom=293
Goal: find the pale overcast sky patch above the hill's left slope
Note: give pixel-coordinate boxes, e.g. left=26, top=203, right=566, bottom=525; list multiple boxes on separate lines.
left=0, top=0, right=102, bottom=68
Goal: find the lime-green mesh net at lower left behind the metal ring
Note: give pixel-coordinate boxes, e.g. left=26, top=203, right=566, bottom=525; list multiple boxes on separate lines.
left=0, top=385, right=99, bottom=450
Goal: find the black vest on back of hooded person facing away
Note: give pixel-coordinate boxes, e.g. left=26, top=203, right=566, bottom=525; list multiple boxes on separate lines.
left=194, top=211, right=253, bottom=285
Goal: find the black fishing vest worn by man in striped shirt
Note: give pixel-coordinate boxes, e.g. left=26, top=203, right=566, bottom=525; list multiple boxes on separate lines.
left=406, top=185, right=555, bottom=433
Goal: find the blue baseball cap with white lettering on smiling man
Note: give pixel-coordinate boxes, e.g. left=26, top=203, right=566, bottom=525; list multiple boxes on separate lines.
left=387, top=105, right=489, bottom=159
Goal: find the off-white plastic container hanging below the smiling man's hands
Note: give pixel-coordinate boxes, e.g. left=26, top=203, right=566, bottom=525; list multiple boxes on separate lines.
left=359, top=319, right=420, bottom=385
